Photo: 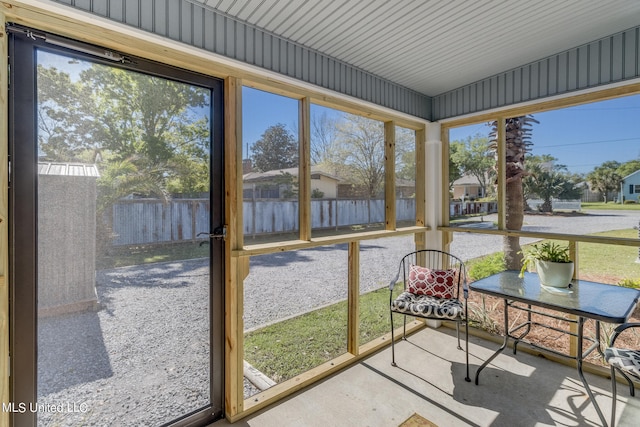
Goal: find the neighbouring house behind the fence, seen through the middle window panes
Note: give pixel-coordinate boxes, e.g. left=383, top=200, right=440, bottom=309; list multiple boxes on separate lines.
left=242, top=166, right=340, bottom=199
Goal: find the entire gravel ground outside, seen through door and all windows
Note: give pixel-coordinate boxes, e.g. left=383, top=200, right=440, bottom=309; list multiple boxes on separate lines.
left=38, top=211, right=640, bottom=426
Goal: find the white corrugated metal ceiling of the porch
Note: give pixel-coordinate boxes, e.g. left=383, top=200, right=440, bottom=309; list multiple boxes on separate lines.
left=190, top=0, right=640, bottom=96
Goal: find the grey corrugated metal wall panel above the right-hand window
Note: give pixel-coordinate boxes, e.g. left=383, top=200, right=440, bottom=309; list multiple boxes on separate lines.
left=432, top=27, right=640, bottom=120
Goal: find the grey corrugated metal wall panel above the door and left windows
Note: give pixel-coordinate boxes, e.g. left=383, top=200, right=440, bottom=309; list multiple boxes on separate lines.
left=51, top=0, right=431, bottom=119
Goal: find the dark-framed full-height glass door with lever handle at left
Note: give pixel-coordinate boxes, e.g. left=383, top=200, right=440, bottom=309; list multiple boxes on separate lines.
left=10, top=29, right=223, bottom=426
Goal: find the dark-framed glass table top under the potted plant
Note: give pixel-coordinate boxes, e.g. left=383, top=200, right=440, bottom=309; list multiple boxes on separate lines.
left=469, top=271, right=640, bottom=323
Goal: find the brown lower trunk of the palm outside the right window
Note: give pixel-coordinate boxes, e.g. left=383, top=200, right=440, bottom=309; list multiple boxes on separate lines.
left=503, top=177, right=524, bottom=270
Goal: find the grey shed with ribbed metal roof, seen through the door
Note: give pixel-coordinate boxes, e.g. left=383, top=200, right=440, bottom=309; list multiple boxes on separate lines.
left=38, top=162, right=99, bottom=316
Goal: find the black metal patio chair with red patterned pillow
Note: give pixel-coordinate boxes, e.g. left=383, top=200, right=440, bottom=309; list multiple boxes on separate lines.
left=389, top=249, right=471, bottom=381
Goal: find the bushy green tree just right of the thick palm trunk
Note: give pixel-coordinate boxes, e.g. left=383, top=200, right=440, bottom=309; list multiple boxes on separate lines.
left=523, top=154, right=580, bottom=212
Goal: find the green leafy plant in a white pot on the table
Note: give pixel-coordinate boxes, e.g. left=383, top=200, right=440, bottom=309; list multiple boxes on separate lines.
left=520, top=242, right=574, bottom=288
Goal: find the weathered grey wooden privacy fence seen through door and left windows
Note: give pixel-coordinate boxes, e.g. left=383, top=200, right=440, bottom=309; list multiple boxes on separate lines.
left=111, top=199, right=416, bottom=246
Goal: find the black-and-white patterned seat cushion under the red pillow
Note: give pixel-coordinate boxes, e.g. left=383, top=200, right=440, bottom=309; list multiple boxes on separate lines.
left=391, top=292, right=464, bottom=320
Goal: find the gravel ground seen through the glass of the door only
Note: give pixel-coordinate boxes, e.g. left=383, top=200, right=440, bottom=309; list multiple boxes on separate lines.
left=38, top=260, right=209, bottom=426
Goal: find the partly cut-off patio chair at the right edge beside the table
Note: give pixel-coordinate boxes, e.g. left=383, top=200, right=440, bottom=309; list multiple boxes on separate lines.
left=604, top=323, right=640, bottom=427
